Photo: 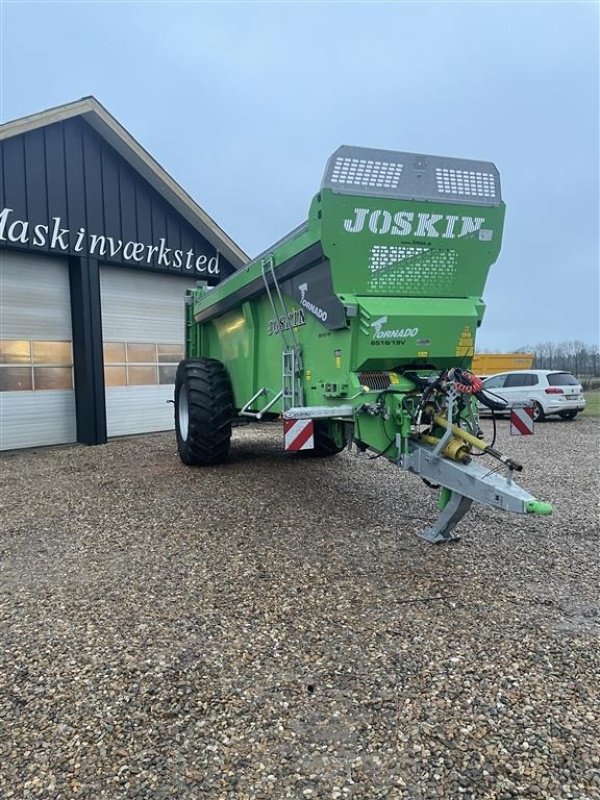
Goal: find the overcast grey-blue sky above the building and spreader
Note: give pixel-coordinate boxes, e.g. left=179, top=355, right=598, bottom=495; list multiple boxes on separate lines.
left=0, top=0, right=599, bottom=349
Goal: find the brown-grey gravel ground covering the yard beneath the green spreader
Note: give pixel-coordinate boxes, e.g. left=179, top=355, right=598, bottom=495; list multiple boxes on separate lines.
left=0, top=419, right=600, bottom=800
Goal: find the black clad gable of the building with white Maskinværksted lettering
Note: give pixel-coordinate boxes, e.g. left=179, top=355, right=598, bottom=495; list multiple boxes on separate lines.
left=0, top=117, right=235, bottom=283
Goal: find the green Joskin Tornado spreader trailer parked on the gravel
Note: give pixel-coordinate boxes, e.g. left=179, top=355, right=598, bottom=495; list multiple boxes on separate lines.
left=175, top=147, right=552, bottom=542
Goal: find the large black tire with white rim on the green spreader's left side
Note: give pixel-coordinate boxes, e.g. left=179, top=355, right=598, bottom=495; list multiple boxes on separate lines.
left=175, top=358, right=233, bottom=467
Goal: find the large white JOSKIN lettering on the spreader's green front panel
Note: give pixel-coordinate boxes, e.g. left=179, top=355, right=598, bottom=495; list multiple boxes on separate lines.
left=344, top=208, right=493, bottom=241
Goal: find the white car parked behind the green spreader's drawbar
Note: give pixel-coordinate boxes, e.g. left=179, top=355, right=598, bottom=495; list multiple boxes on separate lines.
left=480, top=369, right=585, bottom=420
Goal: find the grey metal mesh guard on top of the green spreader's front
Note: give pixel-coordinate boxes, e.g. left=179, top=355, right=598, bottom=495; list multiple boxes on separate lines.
left=321, top=145, right=502, bottom=206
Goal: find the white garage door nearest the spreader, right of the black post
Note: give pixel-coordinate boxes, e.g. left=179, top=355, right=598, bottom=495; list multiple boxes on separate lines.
left=100, top=267, right=195, bottom=436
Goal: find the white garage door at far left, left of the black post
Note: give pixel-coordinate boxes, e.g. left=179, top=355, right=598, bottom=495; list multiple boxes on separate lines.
left=0, top=251, right=77, bottom=450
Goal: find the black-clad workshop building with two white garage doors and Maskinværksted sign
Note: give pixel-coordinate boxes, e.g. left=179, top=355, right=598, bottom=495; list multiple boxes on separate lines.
left=0, top=97, right=247, bottom=450
